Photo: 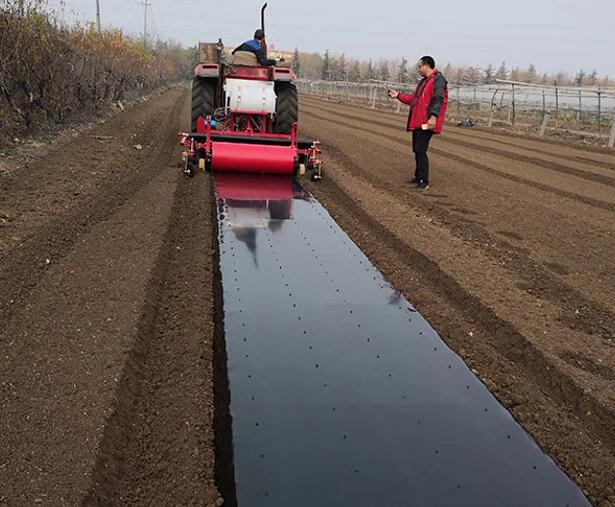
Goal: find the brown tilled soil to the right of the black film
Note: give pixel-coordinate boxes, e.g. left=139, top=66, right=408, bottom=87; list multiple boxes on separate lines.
left=301, top=97, right=615, bottom=506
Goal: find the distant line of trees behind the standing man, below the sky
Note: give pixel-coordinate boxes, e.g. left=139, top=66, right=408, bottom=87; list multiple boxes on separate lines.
left=292, top=49, right=613, bottom=86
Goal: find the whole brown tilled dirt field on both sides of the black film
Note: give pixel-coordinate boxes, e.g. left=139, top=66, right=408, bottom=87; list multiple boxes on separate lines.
left=0, top=88, right=615, bottom=507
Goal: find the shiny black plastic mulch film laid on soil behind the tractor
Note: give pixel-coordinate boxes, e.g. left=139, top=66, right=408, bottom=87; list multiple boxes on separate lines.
left=215, top=173, right=590, bottom=507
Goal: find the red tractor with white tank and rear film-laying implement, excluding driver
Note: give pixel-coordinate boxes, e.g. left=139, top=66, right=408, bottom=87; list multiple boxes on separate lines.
left=179, top=4, right=322, bottom=180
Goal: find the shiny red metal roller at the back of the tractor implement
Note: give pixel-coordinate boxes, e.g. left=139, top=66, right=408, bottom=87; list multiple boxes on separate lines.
left=211, top=142, right=296, bottom=174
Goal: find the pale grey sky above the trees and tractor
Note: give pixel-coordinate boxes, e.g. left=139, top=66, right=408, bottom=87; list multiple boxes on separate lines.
left=50, top=0, right=615, bottom=77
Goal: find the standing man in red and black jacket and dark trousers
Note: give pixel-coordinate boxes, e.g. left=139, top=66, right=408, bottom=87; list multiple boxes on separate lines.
left=389, top=56, right=448, bottom=189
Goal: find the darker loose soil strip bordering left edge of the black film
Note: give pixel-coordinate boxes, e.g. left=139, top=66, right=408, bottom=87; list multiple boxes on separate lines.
left=85, top=178, right=218, bottom=505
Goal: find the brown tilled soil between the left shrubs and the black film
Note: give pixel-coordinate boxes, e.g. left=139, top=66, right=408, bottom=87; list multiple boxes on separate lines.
left=0, top=88, right=219, bottom=505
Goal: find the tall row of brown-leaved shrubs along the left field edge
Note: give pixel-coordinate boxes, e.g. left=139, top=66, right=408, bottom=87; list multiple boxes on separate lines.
left=0, top=0, right=191, bottom=142
